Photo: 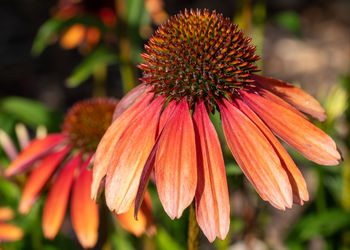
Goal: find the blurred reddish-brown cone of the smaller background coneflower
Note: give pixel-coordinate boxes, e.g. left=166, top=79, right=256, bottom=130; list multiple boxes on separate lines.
left=62, top=98, right=118, bottom=152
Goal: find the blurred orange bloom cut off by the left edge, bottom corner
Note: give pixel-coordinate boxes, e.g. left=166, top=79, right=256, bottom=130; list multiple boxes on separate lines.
left=0, top=207, right=23, bottom=243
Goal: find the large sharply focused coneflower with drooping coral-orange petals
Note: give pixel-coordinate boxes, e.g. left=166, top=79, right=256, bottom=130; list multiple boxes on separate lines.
left=92, top=10, right=341, bottom=241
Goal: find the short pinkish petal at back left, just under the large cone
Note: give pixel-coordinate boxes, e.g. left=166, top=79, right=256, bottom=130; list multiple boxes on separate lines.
left=113, top=84, right=147, bottom=121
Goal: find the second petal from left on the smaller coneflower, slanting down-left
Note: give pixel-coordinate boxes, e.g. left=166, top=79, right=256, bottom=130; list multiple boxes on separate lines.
left=19, top=146, right=71, bottom=214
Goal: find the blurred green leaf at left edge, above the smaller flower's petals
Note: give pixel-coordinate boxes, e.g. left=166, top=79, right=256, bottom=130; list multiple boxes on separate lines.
left=0, top=97, right=59, bottom=128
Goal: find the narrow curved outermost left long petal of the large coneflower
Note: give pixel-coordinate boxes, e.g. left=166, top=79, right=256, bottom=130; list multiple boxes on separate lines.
left=91, top=94, right=153, bottom=200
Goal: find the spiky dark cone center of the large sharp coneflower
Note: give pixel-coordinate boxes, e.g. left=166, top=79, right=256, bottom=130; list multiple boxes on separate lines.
left=139, top=10, right=259, bottom=110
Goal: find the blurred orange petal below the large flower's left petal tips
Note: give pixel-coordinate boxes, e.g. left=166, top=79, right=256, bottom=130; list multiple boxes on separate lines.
left=116, top=192, right=156, bottom=237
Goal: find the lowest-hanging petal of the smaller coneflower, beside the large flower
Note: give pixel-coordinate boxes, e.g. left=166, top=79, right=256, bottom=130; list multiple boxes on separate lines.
left=71, top=156, right=99, bottom=248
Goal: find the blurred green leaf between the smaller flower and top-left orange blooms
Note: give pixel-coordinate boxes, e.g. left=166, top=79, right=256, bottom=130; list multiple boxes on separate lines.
left=66, top=46, right=118, bottom=88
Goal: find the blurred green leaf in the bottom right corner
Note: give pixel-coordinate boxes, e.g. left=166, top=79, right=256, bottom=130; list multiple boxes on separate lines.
left=289, top=209, right=350, bottom=242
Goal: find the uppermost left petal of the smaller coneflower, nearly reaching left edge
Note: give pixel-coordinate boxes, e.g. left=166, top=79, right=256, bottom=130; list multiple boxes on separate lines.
left=4, top=134, right=66, bottom=177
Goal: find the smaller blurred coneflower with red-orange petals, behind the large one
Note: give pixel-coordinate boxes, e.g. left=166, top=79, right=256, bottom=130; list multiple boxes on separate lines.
left=3, top=98, right=154, bottom=248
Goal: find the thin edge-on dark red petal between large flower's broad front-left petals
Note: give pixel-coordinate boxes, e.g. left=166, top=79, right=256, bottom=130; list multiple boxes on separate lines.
left=134, top=101, right=176, bottom=219
